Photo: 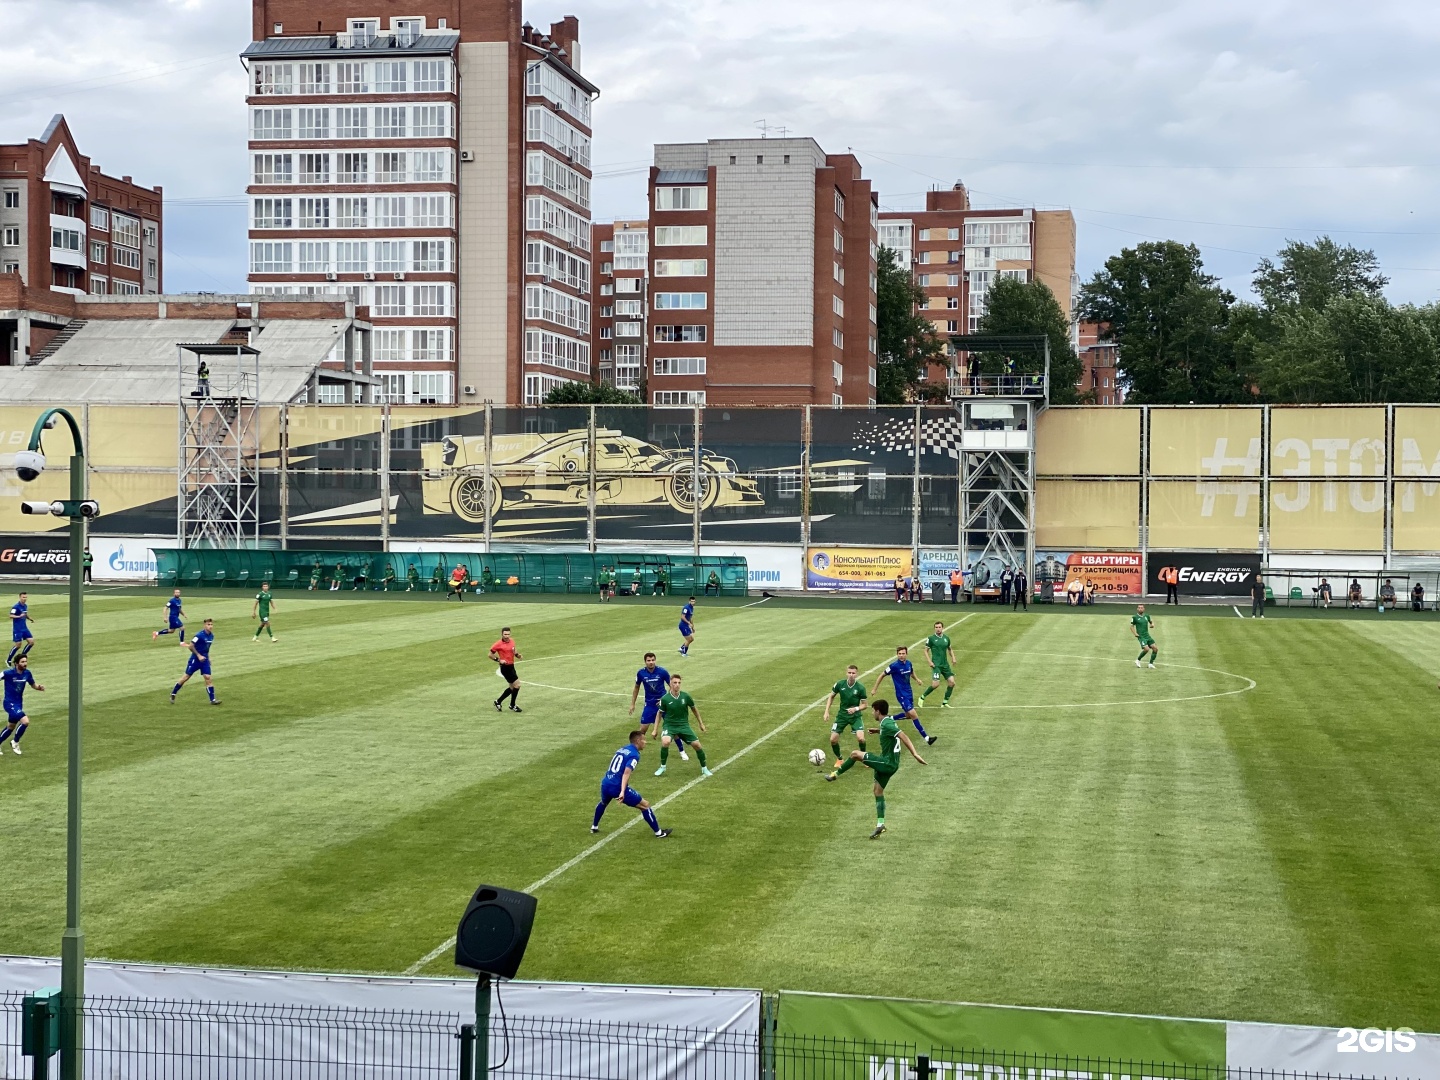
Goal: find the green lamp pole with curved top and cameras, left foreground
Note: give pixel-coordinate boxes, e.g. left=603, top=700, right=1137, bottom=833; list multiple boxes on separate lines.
left=14, top=409, right=99, bottom=1080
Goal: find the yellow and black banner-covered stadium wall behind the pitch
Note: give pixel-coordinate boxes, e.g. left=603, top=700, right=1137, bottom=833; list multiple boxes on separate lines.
left=0, top=403, right=1440, bottom=588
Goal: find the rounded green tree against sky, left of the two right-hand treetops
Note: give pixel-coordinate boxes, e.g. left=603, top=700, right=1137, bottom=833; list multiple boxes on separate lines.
left=1080, top=240, right=1254, bottom=405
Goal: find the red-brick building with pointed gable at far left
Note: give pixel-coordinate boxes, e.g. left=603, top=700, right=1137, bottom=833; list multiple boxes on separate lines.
left=0, top=115, right=164, bottom=366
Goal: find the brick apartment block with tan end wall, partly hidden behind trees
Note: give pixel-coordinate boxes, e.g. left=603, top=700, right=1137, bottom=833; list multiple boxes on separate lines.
left=880, top=183, right=1076, bottom=379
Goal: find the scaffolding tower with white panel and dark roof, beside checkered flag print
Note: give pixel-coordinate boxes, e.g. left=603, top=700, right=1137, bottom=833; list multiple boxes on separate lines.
left=950, top=334, right=1050, bottom=580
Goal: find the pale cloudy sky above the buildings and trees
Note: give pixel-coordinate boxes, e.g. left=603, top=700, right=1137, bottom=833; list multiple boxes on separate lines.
left=0, top=0, right=1440, bottom=304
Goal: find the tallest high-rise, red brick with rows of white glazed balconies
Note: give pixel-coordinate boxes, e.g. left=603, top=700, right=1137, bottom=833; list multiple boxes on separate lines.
left=243, top=0, right=599, bottom=403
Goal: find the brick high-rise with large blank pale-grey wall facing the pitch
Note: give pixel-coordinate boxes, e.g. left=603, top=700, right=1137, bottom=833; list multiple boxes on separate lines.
left=645, top=138, right=878, bottom=405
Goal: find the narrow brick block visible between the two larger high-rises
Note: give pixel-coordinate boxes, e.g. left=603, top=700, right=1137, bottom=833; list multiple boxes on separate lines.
left=593, top=220, right=649, bottom=393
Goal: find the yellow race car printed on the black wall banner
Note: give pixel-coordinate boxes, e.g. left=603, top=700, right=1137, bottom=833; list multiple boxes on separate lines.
left=420, top=428, right=765, bottom=524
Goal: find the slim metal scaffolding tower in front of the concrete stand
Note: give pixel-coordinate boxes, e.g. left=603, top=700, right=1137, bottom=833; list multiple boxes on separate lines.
left=177, top=344, right=261, bottom=547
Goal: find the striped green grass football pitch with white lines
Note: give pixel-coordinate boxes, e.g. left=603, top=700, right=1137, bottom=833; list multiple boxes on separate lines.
left=0, top=590, right=1440, bottom=1031
